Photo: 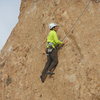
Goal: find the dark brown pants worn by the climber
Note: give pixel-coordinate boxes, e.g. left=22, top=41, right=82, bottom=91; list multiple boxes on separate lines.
left=42, top=49, right=58, bottom=76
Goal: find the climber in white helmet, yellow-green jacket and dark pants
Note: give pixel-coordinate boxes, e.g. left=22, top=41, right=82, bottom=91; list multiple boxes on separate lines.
left=40, top=23, right=64, bottom=82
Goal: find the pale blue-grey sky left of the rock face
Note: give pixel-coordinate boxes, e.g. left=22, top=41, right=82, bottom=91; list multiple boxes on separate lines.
left=0, top=0, right=21, bottom=50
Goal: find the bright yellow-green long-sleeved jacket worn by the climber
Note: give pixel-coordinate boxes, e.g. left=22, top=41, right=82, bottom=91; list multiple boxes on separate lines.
left=47, top=30, right=63, bottom=48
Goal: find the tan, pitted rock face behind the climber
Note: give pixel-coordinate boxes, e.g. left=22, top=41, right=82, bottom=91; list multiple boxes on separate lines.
left=0, top=0, right=100, bottom=100
